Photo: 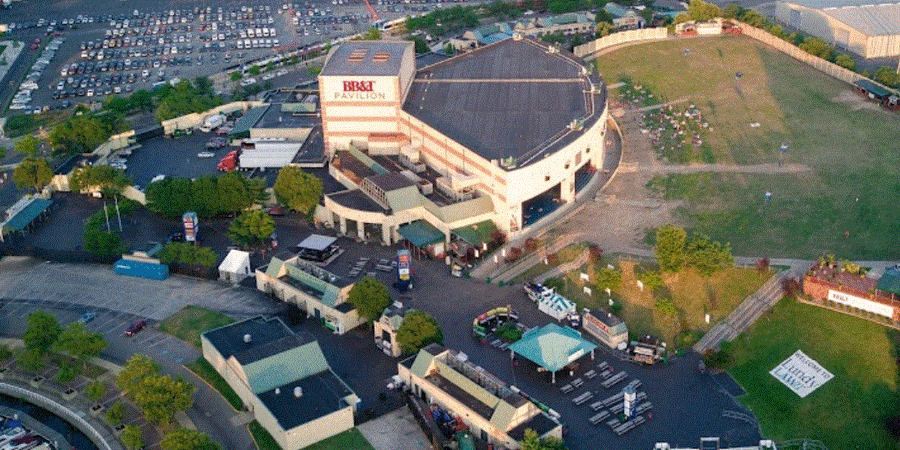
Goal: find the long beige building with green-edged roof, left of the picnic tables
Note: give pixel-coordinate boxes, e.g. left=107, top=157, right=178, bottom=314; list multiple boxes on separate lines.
left=397, top=344, right=562, bottom=449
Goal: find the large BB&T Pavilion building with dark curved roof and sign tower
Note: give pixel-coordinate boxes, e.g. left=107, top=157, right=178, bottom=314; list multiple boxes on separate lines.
left=319, top=36, right=608, bottom=243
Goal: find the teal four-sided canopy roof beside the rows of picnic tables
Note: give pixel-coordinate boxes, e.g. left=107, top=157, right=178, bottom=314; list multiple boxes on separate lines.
left=509, top=323, right=597, bottom=372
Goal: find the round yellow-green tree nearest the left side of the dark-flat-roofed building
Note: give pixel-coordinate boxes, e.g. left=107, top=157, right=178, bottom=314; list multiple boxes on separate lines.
left=129, top=374, right=194, bottom=425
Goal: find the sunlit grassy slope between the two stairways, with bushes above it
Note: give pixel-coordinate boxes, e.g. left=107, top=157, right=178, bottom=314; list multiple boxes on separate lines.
left=544, top=261, right=772, bottom=346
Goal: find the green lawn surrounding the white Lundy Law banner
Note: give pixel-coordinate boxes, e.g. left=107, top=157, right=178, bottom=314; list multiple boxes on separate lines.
left=731, top=299, right=900, bottom=450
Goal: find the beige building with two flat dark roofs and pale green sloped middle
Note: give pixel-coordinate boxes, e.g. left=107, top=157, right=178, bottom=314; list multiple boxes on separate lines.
left=200, top=316, right=359, bottom=450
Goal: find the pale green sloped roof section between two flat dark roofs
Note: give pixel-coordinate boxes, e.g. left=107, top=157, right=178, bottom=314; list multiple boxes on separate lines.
left=244, top=341, right=328, bottom=394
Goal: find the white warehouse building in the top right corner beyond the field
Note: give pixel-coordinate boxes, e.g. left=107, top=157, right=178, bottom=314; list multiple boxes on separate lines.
left=775, top=0, right=900, bottom=58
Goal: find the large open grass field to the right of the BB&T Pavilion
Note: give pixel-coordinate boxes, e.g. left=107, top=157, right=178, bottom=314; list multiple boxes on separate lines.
left=597, top=36, right=900, bottom=259
